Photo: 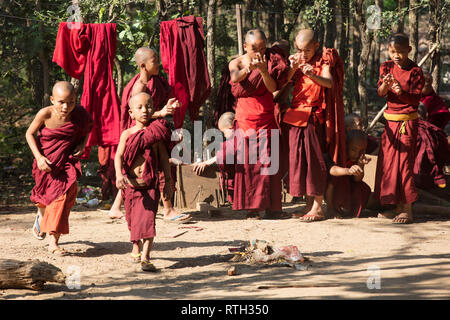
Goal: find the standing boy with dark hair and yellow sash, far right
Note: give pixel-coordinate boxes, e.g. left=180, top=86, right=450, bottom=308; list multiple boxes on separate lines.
left=375, top=33, right=424, bottom=224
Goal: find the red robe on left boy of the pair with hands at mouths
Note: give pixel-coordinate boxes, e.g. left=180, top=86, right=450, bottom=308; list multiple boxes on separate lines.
left=231, top=49, right=287, bottom=211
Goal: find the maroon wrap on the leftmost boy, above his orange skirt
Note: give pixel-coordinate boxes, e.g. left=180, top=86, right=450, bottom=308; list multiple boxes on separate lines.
left=31, top=106, right=92, bottom=206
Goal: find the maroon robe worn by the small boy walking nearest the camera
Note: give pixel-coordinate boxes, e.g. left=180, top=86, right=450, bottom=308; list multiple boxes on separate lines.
left=123, top=119, right=171, bottom=242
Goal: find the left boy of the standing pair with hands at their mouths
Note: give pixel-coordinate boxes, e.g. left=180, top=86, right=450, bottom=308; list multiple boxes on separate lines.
left=229, top=30, right=287, bottom=218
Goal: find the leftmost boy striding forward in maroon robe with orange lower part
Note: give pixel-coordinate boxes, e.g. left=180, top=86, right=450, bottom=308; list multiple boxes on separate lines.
left=25, top=81, right=92, bottom=255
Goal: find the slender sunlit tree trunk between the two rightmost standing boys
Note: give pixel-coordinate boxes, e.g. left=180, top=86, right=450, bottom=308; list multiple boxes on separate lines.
left=355, top=0, right=373, bottom=126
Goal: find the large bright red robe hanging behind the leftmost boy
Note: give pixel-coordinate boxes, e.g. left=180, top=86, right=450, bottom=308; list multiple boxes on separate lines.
left=53, top=22, right=120, bottom=147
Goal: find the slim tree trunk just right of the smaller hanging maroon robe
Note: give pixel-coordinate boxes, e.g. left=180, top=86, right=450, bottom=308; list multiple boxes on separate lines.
left=203, top=0, right=217, bottom=128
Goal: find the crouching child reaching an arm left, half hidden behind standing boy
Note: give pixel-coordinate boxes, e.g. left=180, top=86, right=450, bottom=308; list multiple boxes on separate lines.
left=193, top=112, right=236, bottom=203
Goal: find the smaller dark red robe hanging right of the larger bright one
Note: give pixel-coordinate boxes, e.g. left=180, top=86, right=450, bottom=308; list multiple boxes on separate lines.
left=160, top=16, right=211, bottom=128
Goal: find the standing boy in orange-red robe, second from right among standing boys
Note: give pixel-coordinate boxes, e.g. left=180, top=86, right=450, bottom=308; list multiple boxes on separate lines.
left=283, top=29, right=333, bottom=222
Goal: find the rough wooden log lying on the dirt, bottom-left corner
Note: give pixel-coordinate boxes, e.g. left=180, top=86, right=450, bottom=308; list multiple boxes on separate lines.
left=0, top=259, right=66, bottom=290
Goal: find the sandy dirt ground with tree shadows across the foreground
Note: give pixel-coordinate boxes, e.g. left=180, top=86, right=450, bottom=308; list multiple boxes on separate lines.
left=0, top=200, right=450, bottom=300
